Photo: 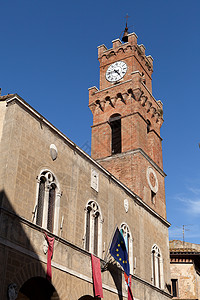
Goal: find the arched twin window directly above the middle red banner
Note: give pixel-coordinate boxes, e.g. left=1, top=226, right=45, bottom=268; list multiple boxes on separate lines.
left=84, top=201, right=103, bottom=257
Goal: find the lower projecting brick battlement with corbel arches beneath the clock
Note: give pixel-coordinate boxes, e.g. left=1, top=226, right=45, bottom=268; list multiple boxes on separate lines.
left=89, top=71, right=163, bottom=134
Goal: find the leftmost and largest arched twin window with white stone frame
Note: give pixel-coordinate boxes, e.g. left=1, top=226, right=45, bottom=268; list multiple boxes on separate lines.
left=35, top=170, right=61, bottom=233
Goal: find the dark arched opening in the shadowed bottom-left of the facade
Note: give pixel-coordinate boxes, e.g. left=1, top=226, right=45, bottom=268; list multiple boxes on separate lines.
left=16, top=276, right=60, bottom=300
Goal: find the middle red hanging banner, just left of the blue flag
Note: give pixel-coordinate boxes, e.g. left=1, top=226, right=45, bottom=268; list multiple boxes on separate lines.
left=91, top=254, right=103, bottom=298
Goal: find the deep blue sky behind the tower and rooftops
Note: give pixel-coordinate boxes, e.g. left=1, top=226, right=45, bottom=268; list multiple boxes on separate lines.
left=0, top=0, right=200, bottom=243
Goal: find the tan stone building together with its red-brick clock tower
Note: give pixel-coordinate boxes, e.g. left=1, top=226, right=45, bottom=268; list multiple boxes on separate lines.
left=0, top=34, right=171, bottom=300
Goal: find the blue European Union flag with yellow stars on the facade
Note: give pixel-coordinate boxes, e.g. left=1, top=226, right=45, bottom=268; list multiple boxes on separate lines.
left=109, top=228, right=130, bottom=276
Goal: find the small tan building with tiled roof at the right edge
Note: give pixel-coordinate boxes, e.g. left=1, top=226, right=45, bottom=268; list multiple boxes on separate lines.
left=169, top=240, right=200, bottom=300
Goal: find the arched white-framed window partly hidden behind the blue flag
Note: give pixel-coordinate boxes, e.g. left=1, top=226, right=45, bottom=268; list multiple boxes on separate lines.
left=120, top=223, right=133, bottom=274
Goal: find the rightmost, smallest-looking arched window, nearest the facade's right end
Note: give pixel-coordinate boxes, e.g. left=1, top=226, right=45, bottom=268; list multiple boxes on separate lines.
left=151, top=245, right=164, bottom=289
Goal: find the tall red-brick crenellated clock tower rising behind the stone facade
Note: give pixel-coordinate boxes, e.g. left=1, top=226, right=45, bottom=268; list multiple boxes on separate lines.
left=89, top=33, right=166, bottom=218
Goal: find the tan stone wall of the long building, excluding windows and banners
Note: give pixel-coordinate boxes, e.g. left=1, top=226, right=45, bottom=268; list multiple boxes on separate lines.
left=0, top=100, right=170, bottom=300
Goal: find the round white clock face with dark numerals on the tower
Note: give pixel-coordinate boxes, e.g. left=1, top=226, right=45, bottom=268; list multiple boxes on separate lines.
left=106, top=61, right=127, bottom=82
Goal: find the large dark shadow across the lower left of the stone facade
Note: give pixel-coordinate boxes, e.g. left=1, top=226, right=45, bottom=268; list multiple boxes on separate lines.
left=0, top=191, right=60, bottom=300
